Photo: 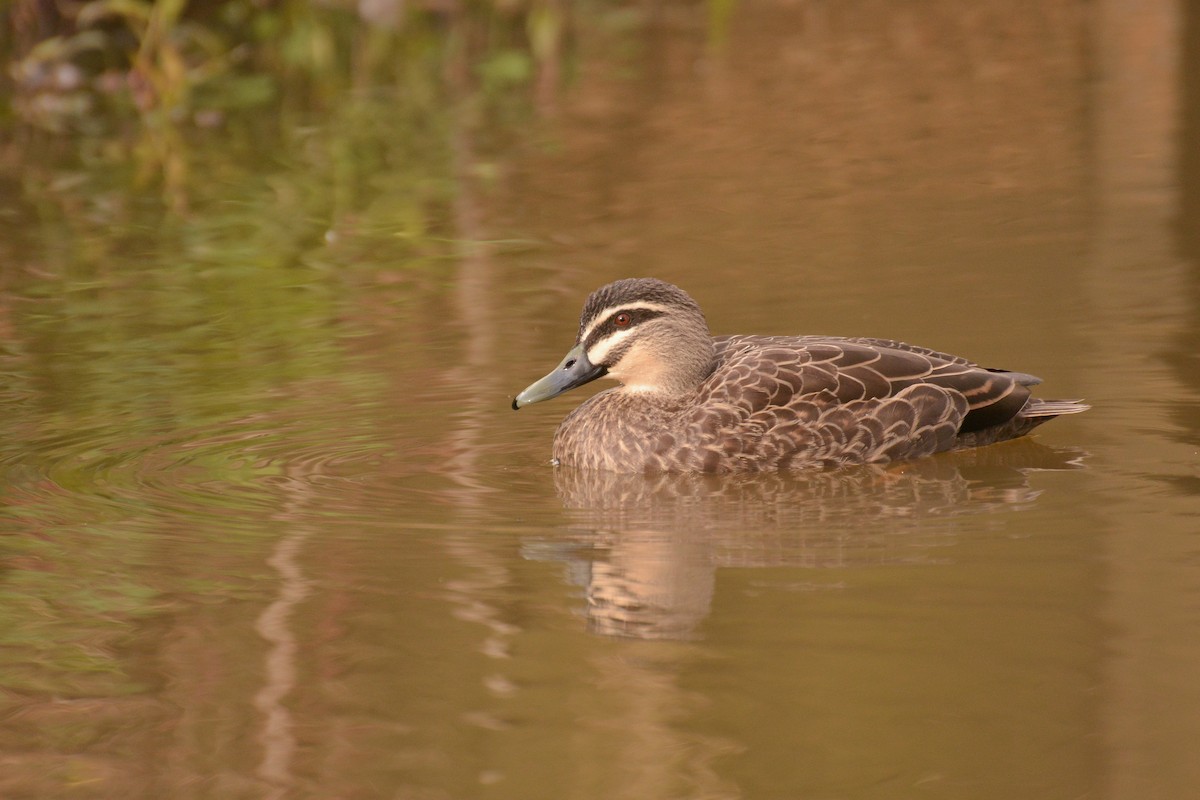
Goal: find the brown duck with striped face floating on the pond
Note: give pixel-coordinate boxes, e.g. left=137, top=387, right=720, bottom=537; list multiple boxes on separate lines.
left=512, top=278, right=1090, bottom=473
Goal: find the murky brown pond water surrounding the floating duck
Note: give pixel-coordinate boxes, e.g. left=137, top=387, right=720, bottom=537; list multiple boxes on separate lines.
left=0, top=0, right=1200, bottom=800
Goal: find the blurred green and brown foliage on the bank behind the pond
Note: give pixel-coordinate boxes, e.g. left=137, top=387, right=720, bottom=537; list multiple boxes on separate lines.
left=4, top=0, right=569, bottom=211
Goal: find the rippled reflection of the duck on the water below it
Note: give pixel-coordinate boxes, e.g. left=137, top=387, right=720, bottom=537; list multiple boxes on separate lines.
left=526, top=440, right=1085, bottom=639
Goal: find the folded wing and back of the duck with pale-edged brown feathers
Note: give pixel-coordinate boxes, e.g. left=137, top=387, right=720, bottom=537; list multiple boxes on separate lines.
left=696, top=336, right=1072, bottom=467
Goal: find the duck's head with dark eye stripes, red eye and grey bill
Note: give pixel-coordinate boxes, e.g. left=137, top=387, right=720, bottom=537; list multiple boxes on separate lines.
left=512, top=278, right=713, bottom=410
